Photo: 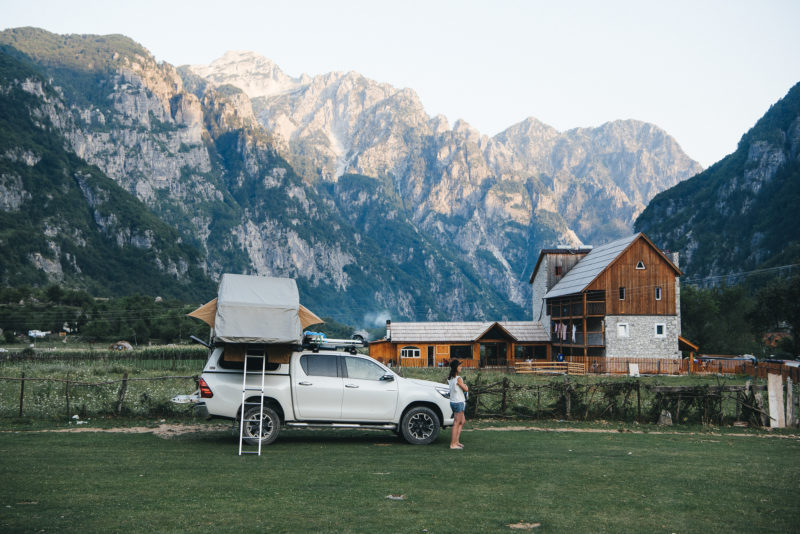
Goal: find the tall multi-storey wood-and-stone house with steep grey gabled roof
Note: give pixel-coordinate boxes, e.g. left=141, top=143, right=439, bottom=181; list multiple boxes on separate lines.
left=530, top=233, right=681, bottom=358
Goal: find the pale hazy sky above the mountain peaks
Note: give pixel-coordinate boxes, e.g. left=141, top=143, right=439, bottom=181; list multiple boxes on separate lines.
left=0, top=0, right=800, bottom=166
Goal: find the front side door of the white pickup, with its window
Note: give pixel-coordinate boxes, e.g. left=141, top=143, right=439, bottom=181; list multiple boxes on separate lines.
left=342, top=356, right=398, bottom=423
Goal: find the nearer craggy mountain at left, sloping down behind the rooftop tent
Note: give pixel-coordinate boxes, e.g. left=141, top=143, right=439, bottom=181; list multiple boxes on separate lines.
left=0, top=28, right=524, bottom=324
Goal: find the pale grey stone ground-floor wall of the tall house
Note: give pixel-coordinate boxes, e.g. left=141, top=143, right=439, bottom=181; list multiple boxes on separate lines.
left=605, top=315, right=681, bottom=358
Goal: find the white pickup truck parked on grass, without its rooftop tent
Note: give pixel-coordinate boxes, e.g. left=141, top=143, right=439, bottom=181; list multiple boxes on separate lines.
left=183, top=345, right=453, bottom=445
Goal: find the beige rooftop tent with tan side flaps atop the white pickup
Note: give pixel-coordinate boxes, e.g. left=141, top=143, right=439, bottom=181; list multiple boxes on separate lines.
left=189, top=274, right=323, bottom=343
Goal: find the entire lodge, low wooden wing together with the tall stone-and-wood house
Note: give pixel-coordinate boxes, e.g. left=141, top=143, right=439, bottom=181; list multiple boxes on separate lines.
left=370, top=233, right=697, bottom=367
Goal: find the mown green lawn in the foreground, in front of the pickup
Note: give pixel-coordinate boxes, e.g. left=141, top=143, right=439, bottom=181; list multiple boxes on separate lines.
left=0, top=421, right=800, bottom=533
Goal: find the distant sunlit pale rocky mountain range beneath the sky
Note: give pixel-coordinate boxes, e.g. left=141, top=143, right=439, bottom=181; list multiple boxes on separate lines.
left=188, top=52, right=702, bottom=305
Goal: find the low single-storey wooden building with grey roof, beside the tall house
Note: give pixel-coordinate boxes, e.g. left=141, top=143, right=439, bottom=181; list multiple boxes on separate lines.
left=369, top=321, right=550, bottom=367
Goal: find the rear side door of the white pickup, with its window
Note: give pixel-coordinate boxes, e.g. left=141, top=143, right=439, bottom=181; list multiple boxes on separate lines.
left=292, top=354, right=344, bottom=421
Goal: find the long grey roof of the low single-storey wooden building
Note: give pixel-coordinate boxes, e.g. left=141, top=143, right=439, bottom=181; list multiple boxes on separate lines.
left=390, top=321, right=550, bottom=343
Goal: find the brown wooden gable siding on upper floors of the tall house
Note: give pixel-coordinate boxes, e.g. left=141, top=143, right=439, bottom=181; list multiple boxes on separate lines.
left=586, top=238, right=677, bottom=315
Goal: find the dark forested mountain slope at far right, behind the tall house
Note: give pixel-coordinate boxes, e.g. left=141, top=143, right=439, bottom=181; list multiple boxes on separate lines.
left=636, top=83, right=800, bottom=283
